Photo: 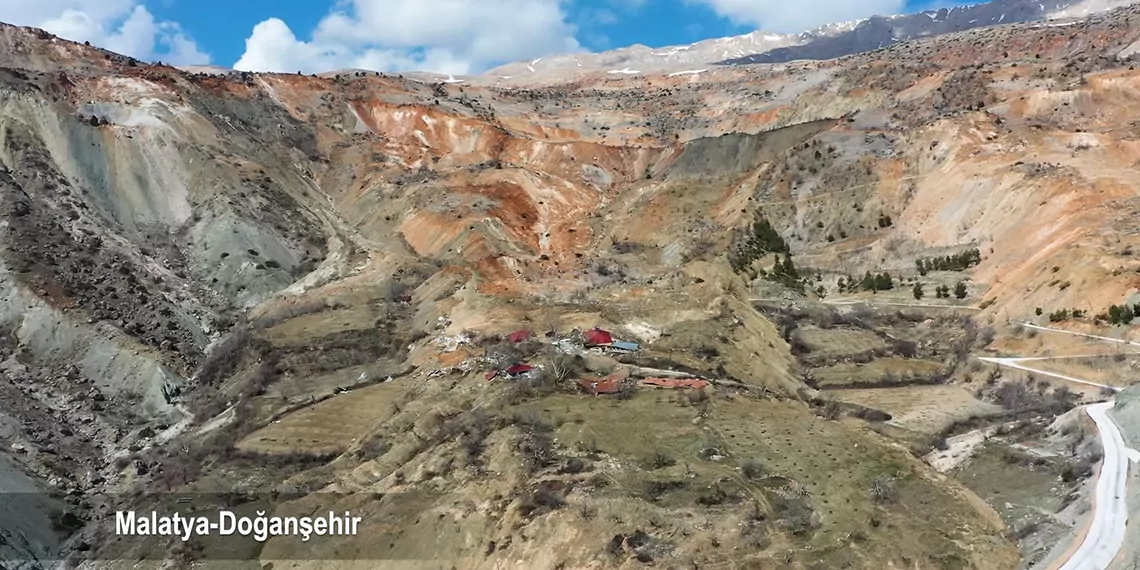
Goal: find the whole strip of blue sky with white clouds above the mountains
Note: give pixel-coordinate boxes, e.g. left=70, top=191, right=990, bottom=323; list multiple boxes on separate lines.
left=0, top=0, right=963, bottom=73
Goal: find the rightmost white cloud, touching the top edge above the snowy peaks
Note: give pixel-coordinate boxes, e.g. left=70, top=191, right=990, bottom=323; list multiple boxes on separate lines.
left=690, top=0, right=906, bottom=33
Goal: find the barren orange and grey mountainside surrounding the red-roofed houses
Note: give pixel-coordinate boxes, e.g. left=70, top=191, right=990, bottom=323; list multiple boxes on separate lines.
left=0, top=1, right=1140, bottom=569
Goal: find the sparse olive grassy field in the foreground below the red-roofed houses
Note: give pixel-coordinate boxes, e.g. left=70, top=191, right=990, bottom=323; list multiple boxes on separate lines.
left=516, top=392, right=1016, bottom=568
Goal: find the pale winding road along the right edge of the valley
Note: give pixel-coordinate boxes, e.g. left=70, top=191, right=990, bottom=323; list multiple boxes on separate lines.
left=978, top=323, right=1140, bottom=570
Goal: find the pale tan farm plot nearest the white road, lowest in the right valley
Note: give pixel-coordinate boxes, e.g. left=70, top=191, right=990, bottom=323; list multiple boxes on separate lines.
left=828, top=385, right=1002, bottom=433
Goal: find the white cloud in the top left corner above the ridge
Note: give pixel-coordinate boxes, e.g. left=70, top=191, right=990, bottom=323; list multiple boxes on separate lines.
left=0, top=0, right=210, bottom=65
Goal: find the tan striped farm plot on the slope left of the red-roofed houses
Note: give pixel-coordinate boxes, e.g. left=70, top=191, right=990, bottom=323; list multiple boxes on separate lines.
left=237, top=382, right=412, bottom=455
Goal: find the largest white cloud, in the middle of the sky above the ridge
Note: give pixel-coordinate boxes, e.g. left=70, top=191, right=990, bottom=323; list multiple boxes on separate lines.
left=234, top=0, right=580, bottom=74
